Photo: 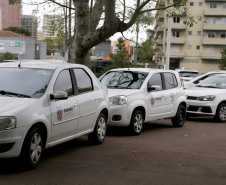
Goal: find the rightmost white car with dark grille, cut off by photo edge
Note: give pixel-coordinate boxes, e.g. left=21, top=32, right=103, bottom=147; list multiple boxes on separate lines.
left=185, top=74, right=226, bottom=122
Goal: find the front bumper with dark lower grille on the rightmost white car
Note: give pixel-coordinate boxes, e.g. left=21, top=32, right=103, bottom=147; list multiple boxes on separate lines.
left=187, top=100, right=216, bottom=116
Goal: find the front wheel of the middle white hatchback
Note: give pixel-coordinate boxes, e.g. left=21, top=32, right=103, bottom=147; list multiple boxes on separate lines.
left=129, top=110, right=144, bottom=135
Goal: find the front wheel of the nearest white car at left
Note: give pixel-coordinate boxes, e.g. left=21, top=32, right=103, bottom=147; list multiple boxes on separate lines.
left=20, top=127, right=43, bottom=169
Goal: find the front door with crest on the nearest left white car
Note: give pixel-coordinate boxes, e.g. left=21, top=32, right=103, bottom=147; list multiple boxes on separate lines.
left=50, top=69, right=79, bottom=142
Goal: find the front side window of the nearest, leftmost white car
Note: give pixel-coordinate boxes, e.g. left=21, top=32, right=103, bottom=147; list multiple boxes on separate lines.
left=53, top=69, right=74, bottom=96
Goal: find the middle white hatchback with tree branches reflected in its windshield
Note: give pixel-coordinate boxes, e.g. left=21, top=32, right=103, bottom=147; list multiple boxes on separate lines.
left=99, top=68, right=187, bottom=134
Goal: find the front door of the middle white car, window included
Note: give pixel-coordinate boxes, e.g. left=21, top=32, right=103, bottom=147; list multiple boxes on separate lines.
left=148, top=73, right=165, bottom=119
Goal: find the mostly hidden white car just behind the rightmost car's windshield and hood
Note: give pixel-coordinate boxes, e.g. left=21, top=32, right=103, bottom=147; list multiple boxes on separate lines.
left=184, top=70, right=226, bottom=89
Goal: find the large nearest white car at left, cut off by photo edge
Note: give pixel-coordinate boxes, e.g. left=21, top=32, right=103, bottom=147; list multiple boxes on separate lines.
left=0, top=61, right=109, bottom=168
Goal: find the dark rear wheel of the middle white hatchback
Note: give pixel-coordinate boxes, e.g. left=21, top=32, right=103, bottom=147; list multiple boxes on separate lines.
left=171, top=105, right=186, bottom=127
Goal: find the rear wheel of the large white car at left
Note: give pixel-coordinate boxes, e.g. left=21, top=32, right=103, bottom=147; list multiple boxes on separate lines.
left=88, top=113, right=107, bottom=144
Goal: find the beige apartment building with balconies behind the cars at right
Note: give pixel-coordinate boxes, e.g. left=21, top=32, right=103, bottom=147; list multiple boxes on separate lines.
left=153, top=0, right=226, bottom=73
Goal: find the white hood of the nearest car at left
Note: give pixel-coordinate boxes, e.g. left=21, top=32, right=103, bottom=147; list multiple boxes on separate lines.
left=0, top=96, right=37, bottom=116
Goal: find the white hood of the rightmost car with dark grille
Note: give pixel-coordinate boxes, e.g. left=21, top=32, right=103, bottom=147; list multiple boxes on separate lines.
left=185, top=87, right=226, bottom=97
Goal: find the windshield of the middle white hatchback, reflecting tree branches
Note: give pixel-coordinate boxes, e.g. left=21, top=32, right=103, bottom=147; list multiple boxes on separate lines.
left=100, top=71, right=148, bottom=89
